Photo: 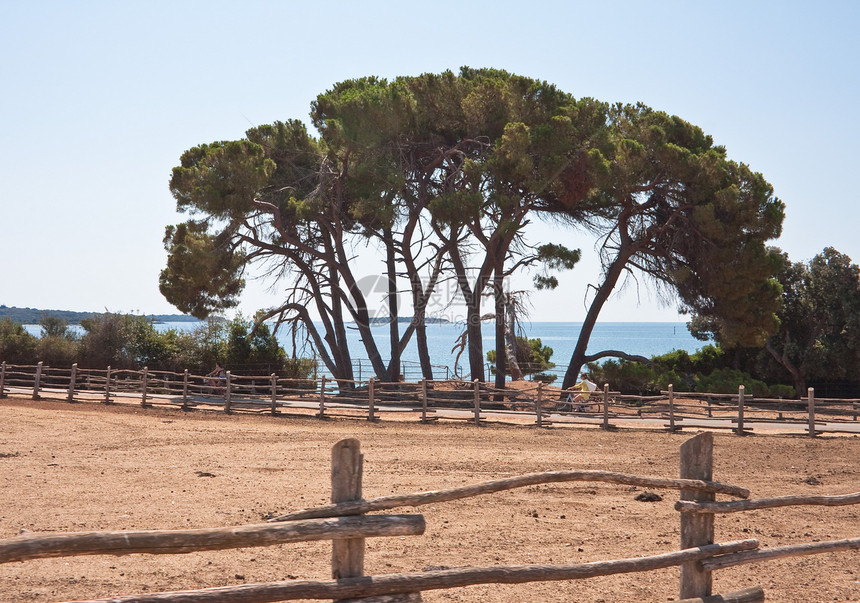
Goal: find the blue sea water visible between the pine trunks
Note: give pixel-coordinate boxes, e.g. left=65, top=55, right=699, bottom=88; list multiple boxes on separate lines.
left=25, top=322, right=711, bottom=380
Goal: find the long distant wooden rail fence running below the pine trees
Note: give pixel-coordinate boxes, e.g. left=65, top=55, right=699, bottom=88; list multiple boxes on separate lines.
left=0, top=362, right=860, bottom=436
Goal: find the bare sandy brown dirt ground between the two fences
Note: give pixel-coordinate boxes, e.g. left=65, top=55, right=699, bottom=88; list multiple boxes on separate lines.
left=0, top=398, right=860, bottom=603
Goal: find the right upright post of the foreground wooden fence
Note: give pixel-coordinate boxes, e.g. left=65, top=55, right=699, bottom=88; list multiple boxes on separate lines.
left=680, top=431, right=715, bottom=599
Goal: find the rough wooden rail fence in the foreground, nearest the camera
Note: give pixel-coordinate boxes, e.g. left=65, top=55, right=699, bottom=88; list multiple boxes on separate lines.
left=0, top=432, right=860, bottom=603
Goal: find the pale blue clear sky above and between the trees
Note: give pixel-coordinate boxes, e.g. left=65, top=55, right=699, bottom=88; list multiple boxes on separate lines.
left=0, top=0, right=860, bottom=322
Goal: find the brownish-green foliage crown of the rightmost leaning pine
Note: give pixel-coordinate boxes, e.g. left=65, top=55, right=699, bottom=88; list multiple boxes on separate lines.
left=607, top=105, right=784, bottom=345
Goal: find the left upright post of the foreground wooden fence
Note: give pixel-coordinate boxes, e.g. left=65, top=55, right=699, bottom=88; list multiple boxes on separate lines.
left=331, top=438, right=364, bottom=580
